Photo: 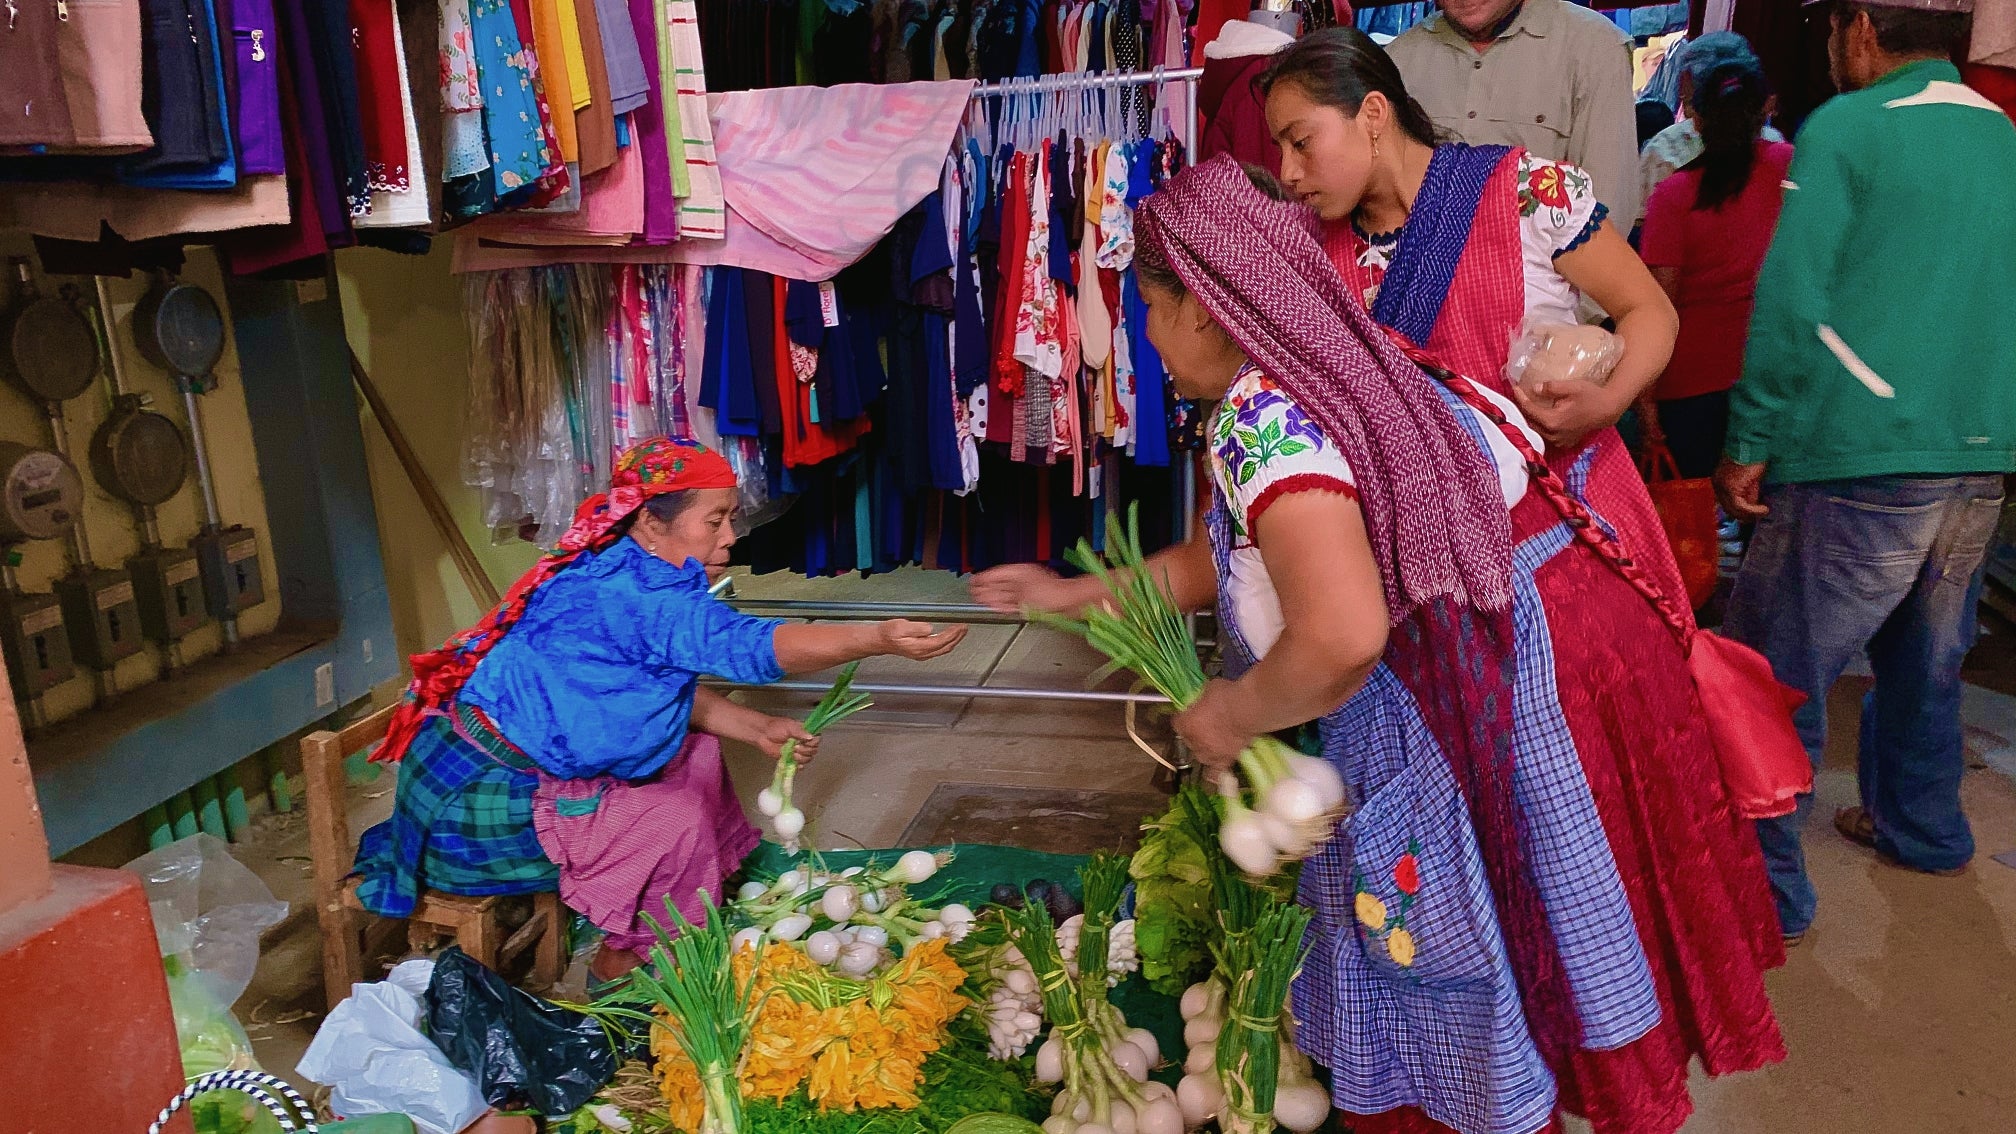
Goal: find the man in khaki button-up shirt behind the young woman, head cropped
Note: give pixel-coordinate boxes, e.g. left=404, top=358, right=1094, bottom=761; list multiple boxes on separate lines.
left=1387, top=0, right=1645, bottom=232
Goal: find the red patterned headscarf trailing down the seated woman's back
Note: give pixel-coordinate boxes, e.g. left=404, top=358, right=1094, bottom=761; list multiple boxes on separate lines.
left=371, top=438, right=736, bottom=763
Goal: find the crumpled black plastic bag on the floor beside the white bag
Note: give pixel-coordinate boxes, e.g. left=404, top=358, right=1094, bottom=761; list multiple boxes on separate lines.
left=427, top=946, right=617, bottom=1116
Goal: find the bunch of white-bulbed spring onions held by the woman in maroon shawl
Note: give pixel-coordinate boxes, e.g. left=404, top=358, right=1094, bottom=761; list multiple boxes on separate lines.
left=1030, top=508, right=1345, bottom=878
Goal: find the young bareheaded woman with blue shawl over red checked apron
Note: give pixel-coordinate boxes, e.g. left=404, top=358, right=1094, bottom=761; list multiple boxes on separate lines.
left=1260, top=28, right=1683, bottom=629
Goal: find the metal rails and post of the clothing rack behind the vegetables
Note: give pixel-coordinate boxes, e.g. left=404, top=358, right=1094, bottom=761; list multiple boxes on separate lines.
left=710, top=67, right=1204, bottom=704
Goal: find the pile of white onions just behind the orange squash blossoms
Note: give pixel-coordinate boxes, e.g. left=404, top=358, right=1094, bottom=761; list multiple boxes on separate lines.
left=730, top=852, right=974, bottom=979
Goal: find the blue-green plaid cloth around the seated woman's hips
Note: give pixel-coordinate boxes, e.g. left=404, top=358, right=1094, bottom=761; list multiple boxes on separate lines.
left=357, top=706, right=560, bottom=918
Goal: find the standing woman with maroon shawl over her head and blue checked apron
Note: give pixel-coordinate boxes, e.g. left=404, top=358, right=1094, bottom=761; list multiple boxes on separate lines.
left=974, top=159, right=1784, bottom=1134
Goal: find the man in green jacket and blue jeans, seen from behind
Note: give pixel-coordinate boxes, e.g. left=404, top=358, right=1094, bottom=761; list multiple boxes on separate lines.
left=1716, top=0, right=2016, bottom=940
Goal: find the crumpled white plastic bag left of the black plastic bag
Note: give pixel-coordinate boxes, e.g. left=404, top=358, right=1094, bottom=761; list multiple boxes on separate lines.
left=294, top=960, right=490, bottom=1134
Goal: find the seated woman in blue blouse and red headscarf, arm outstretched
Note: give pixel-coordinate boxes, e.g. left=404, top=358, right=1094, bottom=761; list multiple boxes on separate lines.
left=357, top=438, right=966, bottom=979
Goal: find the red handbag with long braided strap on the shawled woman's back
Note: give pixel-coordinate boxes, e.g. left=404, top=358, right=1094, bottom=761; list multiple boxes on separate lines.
left=1409, top=361, right=1812, bottom=819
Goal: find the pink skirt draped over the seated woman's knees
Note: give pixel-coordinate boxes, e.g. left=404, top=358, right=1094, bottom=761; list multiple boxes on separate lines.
left=532, top=732, right=762, bottom=952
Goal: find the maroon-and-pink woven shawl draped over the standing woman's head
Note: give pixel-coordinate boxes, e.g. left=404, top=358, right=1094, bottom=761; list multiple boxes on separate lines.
left=1135, top=157, right=1574, bottom=1065
